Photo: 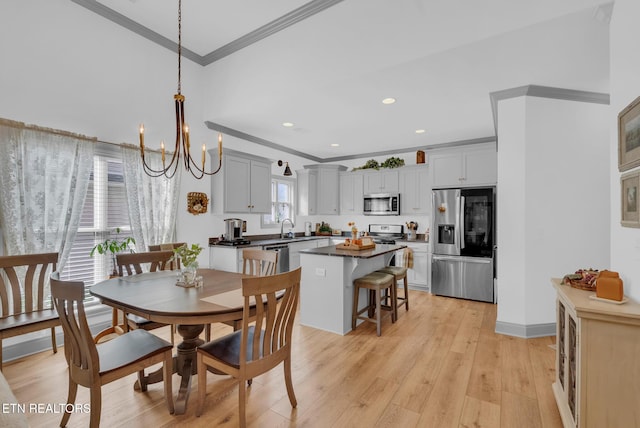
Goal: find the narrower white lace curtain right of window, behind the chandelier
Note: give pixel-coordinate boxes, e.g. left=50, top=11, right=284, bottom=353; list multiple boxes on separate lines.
left=122, top=146, right=181, bottom=251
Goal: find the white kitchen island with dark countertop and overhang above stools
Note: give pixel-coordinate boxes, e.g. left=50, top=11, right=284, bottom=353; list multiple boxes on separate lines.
left=300, top=244, right=406, bottom=335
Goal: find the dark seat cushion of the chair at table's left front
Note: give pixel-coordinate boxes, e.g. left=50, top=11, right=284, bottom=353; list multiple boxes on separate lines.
left=98, top=330, right=173, bottom=374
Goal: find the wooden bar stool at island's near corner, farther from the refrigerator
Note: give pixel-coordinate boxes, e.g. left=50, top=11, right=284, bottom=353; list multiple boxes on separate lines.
left=351, top=272, right=397, bottom=336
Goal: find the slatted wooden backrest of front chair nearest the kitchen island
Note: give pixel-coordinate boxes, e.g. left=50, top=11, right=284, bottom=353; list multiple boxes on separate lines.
left=240, top=268, right=301, bottom=366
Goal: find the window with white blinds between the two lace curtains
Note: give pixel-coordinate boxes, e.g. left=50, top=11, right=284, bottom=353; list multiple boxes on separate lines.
left=61, top=146, right=131, bottom=297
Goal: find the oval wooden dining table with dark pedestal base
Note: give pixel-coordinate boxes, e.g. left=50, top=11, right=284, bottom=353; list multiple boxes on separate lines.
left=90, top=269, right=246, bottom=414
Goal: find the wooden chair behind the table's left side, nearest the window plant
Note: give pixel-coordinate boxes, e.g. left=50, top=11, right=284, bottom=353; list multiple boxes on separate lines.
left=95, top=250, right=175, bottom=343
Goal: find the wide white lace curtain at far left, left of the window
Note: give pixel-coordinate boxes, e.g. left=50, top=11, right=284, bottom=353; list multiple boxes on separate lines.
left=0, top=119, right=95, bottom=269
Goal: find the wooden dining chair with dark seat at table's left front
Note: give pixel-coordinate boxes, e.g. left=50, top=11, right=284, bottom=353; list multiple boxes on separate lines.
left=51, top=272, right=174, bottom=428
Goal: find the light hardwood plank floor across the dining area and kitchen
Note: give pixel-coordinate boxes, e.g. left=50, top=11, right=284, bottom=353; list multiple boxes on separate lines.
left=4, top=291, right=562, bottom=428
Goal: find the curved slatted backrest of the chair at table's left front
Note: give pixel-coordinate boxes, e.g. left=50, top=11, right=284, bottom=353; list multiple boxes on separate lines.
left=51, top=272, right=100, bottom=381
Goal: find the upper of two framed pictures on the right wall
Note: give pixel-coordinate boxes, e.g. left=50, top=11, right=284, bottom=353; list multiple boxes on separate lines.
left=618, top=97, right=640, bottom=171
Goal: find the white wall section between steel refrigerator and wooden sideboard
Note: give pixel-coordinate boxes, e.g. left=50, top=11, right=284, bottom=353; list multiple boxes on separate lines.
left=497, top=96, right=610, bottom=328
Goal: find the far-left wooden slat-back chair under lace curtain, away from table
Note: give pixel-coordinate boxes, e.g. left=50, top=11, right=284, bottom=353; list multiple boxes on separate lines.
left=0, top=253, right=60, bottom=371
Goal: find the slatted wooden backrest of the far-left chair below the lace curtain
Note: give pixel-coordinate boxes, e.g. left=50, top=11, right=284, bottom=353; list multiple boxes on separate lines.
left=0, top=253, right=58, bottom=318
